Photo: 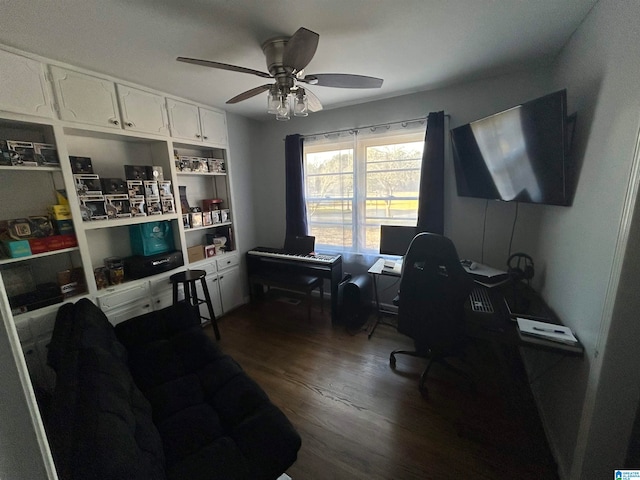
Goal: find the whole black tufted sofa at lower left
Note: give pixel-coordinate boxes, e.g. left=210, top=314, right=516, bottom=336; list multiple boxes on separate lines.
left=45, top=299, right=300, bottom=480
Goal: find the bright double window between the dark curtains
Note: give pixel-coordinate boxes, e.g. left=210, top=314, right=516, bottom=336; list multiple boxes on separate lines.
left=304, top=126, right=425, bottom=254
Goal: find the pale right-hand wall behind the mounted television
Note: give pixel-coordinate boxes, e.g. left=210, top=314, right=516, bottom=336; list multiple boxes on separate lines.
left=536, top=0, right=640, bottom=479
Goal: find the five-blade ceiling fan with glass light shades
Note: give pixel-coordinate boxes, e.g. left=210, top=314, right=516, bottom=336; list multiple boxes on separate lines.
left=177, top=27, right=383, bottom=120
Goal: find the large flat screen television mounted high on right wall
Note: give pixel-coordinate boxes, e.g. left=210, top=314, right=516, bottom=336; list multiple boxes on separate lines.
left=451, top=90, right=571, bottom=205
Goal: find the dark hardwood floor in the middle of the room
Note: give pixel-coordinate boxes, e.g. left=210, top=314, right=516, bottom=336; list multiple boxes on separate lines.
left=207, top=296, right=558, bottom=480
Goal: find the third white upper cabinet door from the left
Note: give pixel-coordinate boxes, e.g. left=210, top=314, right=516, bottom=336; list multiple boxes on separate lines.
left=117, top=84, right=169, bottom=135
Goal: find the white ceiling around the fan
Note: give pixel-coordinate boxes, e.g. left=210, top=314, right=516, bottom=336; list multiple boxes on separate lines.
left=0, top=0, right=597, bottom=119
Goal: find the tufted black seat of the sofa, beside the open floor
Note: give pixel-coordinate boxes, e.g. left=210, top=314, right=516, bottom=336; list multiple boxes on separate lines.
left=116, top=312, right=300, bottom=480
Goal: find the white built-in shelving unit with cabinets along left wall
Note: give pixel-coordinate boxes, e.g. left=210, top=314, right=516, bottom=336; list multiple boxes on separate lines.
left=0, top=46, right=243, bottom=390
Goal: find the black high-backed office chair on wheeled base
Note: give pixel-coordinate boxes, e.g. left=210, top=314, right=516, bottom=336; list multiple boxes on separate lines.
left=389, top=233, right=473, bottom=395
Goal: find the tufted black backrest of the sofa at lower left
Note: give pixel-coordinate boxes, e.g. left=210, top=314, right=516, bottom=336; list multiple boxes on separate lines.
left=46, top=299, right=165, bottom=480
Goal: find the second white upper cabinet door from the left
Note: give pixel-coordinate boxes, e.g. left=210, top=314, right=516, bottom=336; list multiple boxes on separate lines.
left=51, top=66, right=120, bottom=129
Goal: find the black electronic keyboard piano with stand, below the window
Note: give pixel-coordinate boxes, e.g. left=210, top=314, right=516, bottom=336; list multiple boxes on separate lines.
left=247, top=247, right=342, bottom=323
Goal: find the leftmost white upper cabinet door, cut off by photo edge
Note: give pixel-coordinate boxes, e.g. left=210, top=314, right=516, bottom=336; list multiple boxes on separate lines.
left=0, top=50, right=53, bottom=118
